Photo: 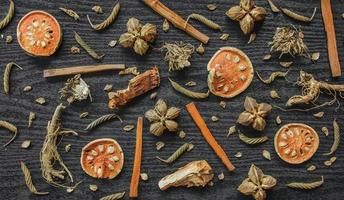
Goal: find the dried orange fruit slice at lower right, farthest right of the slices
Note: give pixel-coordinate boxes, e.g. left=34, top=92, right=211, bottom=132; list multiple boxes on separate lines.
left=275, top=123, right=319, bottom=164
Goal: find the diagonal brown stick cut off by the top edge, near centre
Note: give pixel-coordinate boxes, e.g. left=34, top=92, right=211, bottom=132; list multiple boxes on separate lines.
left=143, top=0, right=209, bottom=44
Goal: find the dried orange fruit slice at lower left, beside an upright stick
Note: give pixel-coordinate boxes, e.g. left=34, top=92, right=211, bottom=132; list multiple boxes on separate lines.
left=80, top=138, right=124, bottom=179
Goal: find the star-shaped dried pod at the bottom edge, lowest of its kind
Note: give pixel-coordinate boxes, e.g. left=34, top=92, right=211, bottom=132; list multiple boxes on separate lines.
left=238, top=164, right=277, bottom=200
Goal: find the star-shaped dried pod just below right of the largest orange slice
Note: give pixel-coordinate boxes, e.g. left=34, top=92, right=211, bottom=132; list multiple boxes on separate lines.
left=237, top=96, right=272, bottom=131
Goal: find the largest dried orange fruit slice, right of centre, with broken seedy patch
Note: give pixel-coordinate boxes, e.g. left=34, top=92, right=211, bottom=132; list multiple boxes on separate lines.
left=207, top=47, right=254, bottom=98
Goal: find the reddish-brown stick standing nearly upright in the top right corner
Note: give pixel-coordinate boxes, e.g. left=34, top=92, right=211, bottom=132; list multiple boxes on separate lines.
left=321, top=0, right=341, bottom=77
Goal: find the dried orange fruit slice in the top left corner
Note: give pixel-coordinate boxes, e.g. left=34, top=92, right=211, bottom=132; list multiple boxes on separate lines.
left=17, top=10, right=62, bottom=56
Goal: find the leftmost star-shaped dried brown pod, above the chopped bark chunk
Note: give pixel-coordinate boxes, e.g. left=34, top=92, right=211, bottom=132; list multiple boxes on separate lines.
left=119, top=17, right=157, bottom=55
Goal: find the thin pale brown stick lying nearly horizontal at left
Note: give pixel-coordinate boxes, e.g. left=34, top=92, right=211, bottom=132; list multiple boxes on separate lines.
left=43, top=64, right=125, bottom=78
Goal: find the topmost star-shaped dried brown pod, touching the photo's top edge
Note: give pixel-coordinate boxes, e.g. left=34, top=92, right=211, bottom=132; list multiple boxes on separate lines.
left=226, top=0, right=266, bottom=34
